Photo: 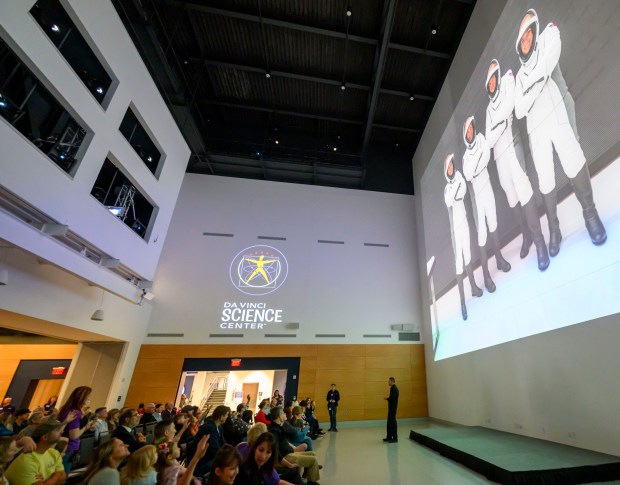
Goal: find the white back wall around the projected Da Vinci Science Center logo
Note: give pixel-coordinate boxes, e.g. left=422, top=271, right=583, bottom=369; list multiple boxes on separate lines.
left=146, top=174, right=420, bottom=344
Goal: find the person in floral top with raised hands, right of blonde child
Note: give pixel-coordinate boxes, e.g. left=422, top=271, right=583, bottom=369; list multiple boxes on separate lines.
left=155, top=435, right=209, bottom=485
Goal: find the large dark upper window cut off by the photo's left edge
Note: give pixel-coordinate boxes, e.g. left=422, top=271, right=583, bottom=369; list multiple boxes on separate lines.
left=0, top=39, right=86, bottom=174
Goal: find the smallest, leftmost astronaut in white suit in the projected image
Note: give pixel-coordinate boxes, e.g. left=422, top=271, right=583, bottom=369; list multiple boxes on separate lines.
left=443, top=153, right=482, bottom=320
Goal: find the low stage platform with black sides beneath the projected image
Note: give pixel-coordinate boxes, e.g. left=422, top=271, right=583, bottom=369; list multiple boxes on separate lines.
left=409, top=426, right=620, bottom=485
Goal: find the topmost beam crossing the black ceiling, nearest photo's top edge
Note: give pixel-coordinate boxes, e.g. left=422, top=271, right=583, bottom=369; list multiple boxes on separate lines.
left=177, top=0, right=452, bottom=59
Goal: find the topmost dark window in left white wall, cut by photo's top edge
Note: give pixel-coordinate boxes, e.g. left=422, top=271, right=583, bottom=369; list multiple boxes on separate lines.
left=30, top=0, right=112, bottom=104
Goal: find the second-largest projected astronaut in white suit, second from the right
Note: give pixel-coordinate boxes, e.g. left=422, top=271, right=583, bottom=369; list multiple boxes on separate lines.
left=485, top=59, right=549, bottom=271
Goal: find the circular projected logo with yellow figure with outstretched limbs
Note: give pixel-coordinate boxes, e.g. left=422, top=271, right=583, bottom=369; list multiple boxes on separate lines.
left=230, top=246, right=288, bottom=296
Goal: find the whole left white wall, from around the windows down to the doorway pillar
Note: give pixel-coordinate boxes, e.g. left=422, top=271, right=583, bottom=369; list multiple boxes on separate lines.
left=0, top=0, right=189, bottom=407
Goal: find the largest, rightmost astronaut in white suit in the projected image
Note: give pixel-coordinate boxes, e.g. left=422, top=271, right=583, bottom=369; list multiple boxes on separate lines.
left=515, top=9, right=607, bottom=256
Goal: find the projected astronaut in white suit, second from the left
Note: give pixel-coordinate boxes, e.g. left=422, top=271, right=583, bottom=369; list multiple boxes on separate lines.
left=463, top=116, right=510, bottom=293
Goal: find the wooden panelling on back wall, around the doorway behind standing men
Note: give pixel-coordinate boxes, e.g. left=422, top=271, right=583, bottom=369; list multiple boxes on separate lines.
left=125, top=344, right=428, bottom=421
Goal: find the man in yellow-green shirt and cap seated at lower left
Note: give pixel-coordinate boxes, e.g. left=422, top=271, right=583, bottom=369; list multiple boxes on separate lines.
left=5, top=420, right=67, bottom=485
